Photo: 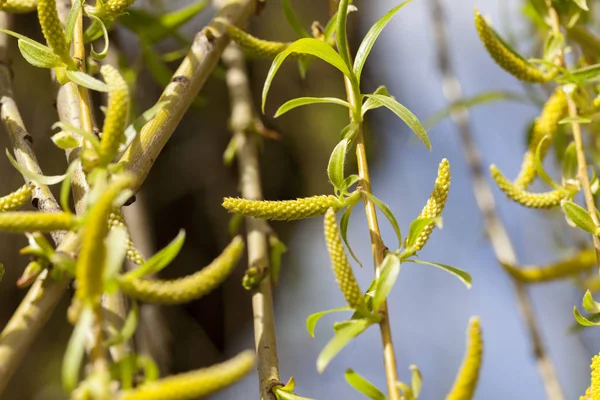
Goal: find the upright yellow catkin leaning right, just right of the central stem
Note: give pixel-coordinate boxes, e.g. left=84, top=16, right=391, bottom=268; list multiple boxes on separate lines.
left=414, top=158, right=451, bottom=251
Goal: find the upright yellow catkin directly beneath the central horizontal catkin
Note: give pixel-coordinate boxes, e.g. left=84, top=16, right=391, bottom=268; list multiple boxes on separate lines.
left=324, top=208, right=366, bottom=310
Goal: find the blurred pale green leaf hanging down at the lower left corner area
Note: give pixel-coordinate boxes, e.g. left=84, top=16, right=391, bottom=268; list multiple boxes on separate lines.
left=62, top=307, right=94, bottom=393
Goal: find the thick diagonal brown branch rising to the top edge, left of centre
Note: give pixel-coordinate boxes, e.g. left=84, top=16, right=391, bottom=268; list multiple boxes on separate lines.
left=120, top=0, right=257, bottom=191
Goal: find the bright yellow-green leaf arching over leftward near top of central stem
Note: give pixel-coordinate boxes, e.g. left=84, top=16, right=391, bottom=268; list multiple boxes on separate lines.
left=262, top=38, right=351, bottom=113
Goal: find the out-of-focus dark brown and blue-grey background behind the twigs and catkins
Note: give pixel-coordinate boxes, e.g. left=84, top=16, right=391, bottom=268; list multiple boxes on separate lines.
left=0, top=0, right=598, bottom=400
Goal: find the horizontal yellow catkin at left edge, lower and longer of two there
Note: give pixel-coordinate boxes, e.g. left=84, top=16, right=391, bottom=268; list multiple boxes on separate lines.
left=0, top=211, right=79, bottom=233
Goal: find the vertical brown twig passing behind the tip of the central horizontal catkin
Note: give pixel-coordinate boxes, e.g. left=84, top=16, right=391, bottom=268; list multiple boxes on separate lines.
left=223, top=43, right=281, bottom=400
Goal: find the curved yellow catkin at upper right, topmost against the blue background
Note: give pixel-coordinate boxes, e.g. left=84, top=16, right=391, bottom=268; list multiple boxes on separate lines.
left=475, top=10, right=556, bottom=83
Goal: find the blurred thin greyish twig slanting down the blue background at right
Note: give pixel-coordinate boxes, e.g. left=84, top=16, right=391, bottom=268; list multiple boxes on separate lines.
left=430, top=0, right=565, bottom=400
